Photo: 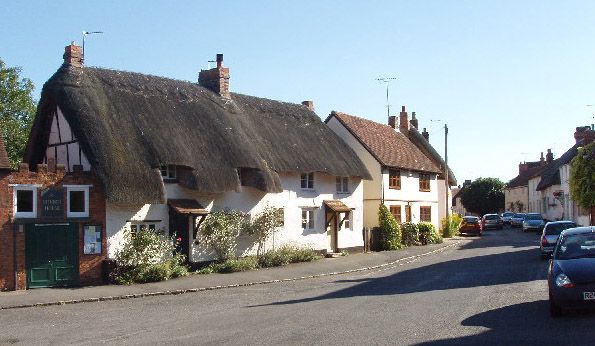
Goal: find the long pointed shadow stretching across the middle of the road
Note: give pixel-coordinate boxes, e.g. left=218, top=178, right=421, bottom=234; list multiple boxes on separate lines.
left=251, top=249, right=547, bottom=307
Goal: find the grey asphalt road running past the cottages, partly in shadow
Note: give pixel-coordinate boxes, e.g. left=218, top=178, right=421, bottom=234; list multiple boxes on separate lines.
left=0, top=229, right=595, bottom=345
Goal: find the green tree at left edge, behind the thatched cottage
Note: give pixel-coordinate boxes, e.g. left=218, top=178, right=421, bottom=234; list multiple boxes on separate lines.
left=0, top=59, right=35, bottom=168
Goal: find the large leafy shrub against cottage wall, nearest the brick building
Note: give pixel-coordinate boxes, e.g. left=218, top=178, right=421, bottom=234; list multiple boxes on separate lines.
left=110, top=228, right=188, bottom=285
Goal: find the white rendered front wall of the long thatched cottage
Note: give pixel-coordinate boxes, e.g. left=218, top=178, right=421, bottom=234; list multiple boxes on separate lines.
left=106, top=173, right=363, bottom=262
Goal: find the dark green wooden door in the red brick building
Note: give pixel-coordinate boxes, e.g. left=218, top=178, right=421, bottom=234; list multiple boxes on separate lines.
left=25, top=224, right=78, bottom=288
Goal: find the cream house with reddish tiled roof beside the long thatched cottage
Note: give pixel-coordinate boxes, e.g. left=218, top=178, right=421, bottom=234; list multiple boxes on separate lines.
left=325, top=107, right=454, bottom=228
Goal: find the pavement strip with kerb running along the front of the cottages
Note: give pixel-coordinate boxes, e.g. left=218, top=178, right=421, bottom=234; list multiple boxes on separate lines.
left=0, top=238, right=467, bottom=310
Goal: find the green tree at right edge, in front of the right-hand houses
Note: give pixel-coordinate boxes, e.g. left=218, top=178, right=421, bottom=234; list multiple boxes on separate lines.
left=570, top=142, right=595, bottom=209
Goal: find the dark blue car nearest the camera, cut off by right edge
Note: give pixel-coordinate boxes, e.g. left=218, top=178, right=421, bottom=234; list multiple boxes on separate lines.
left=548, top=226, right=595, bottom=316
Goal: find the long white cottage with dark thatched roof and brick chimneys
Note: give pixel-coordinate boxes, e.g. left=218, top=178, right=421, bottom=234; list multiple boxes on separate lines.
left=18, top=45, right=370, bottom=282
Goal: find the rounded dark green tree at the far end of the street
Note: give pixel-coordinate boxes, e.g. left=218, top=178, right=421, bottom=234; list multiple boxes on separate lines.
left=461, top=178, right=504, bottom=215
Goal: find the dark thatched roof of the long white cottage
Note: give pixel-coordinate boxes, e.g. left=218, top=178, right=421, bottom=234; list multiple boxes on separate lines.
left=26, top=65, right=370, bottom=203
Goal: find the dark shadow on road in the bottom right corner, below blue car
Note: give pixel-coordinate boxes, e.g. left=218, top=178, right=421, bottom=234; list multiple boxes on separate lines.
left=419, top=300, right=595, bottom=345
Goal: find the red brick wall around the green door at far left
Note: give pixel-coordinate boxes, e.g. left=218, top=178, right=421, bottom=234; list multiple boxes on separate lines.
left=0, top=165, right=107, bottom=290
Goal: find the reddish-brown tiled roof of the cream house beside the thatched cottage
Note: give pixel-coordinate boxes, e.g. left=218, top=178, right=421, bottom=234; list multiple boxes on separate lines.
left=331, top=112, right=441, bottom=173
